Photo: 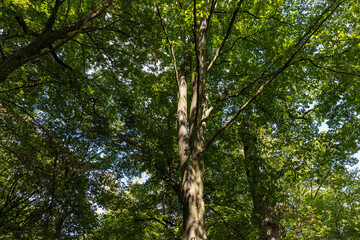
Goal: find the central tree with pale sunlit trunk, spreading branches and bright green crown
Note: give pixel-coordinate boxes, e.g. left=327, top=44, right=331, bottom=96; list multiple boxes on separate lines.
left=151, top=0, right=358, bottom=240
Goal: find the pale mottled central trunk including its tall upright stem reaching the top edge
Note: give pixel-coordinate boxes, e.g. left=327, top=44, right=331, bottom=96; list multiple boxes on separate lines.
left=178, top=1, right=209, bottom=240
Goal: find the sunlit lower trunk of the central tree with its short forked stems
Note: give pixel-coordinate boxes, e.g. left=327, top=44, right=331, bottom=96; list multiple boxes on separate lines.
left=177, top=53, right=207, bottom=240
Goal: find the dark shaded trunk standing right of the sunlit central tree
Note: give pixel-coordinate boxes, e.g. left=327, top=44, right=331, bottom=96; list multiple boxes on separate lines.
left=243, top=122, right=281, bottom=240
